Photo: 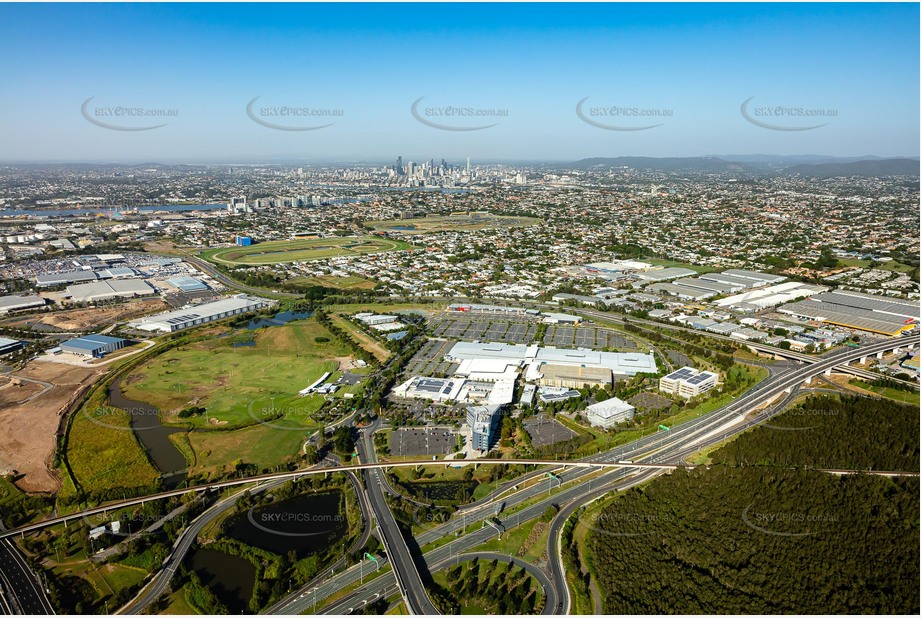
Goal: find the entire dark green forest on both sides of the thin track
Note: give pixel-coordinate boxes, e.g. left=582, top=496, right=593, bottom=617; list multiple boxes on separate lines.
left=576, top=397, right=921, bottom=614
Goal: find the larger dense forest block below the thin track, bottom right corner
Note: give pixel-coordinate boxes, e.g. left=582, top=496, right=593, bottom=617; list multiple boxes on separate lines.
left=585, top=467, right=919, bottom=614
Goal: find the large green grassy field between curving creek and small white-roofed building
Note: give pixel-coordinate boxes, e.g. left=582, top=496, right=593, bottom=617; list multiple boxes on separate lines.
left=122, top=319, right=350, bottom=433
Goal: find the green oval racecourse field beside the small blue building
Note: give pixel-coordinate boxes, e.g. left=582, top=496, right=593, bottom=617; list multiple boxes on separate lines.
left=207, top=236, right=411, bottom=266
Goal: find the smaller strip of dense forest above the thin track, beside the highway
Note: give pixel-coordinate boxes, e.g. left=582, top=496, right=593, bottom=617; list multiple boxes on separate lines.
left=713, top=396, right=921, bottom=472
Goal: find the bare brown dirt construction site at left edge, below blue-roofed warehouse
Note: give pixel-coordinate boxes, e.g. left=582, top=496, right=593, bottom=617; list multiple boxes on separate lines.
left=0, top=361, right=101, bottom=492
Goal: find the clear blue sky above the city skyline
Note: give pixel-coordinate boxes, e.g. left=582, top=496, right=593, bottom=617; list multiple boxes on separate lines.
left=0, top=3, right=921, bottom=162
